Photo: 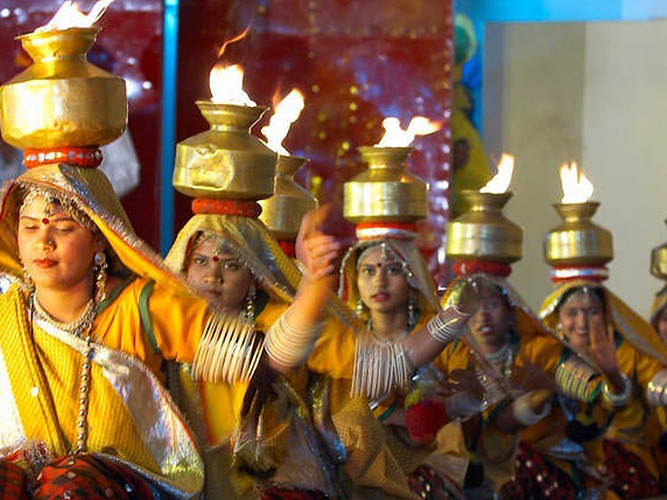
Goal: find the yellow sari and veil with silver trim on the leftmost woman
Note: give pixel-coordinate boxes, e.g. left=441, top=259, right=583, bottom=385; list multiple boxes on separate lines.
left=0, top=164, right=209, bottom=498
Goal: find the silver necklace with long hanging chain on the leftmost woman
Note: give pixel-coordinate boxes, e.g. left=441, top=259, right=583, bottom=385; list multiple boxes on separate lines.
left=30, top=293, right=97, bottom=455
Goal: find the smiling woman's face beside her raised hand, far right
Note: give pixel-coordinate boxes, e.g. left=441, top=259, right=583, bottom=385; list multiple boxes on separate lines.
left=558, top=292, right=604, bottom=348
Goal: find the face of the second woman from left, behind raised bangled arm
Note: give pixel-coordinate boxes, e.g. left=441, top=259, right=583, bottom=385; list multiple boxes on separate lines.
left=186, top=238, right=254, bottom=312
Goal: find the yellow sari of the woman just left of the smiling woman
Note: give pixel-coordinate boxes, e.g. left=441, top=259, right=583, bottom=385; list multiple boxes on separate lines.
left=436, top=274, right=599, bottom=490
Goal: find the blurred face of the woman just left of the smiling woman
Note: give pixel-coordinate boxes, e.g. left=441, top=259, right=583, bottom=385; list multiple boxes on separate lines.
left=468, top=286, right=511, bottom=350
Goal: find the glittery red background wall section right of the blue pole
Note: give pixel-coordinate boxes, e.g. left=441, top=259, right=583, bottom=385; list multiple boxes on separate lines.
left=176, top=0, right=453, bottom=282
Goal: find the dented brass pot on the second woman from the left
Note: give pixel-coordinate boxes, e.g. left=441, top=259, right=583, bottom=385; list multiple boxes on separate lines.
left=173, top=101, right=277, bottom=200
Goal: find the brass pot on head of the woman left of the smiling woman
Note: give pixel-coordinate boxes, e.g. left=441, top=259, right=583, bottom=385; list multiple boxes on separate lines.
left=446, top=189, right=523, bottom=264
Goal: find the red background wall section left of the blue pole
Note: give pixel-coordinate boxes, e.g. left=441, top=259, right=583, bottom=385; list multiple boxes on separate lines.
left=0, top=0, right=163, bottom=248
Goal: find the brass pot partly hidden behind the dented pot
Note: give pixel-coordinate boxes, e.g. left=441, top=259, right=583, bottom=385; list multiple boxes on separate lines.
left=259, top=155, right=317, bottom=241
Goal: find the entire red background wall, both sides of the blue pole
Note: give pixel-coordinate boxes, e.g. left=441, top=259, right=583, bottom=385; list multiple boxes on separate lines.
left=0, top=0, right=453, bottom=282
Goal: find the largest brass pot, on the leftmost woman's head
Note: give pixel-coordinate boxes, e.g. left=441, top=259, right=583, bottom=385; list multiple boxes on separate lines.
left=0, top=28, right=127, bottom=149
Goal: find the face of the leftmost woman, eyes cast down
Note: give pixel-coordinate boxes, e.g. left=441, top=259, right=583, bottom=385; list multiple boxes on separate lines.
left=17, top=197, right=104, bottom=292
